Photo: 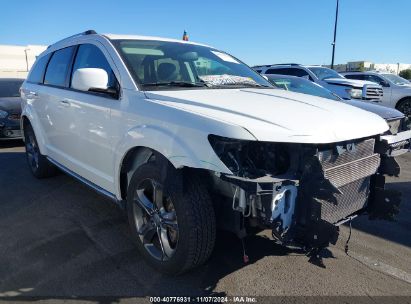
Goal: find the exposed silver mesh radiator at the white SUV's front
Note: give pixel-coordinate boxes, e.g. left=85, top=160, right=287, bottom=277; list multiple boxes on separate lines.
left=317, top=139, right=380, bottom=224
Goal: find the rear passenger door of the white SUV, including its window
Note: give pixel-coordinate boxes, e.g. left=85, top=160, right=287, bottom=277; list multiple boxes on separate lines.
left=41, top=46, right=76, bottom=164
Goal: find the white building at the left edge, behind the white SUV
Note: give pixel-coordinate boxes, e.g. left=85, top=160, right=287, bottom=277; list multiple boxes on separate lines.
left=0, top=45, right=47, bottom=78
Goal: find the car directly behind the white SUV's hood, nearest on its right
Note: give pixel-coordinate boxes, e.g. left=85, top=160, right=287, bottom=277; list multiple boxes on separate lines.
left=266, top=74, right=411, bottom=156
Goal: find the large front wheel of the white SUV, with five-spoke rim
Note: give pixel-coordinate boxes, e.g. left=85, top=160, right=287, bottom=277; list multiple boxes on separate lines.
left=127, top=161, right=216, bottom=275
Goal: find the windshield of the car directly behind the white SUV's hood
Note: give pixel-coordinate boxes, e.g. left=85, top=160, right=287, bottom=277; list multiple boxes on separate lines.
left=267, top=75, right=341, bottom=101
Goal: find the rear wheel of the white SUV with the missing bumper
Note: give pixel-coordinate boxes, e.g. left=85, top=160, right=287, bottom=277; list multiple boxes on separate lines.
left=24, top=123, right=58, bottom=178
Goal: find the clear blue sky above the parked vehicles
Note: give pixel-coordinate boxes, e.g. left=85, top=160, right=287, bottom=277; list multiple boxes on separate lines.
left=0, top=0, right=411, bottom=65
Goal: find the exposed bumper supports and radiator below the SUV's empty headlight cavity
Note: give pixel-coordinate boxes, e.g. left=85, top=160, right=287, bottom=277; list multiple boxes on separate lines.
left=221, top=139, right=401, bottom=251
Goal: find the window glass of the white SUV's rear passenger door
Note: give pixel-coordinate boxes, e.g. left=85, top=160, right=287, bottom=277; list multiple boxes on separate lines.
left=44, top=46, right=74, bottom=87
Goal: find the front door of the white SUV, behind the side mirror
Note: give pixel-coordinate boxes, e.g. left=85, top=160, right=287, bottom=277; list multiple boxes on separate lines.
left=67, top=42, right=120, bottom=193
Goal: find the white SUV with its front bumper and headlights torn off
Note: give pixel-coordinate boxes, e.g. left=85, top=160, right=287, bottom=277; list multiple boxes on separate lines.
left=21, top=31, right=400, bottom=274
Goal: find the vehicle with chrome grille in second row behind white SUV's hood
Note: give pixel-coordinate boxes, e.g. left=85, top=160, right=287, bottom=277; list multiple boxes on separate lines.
left=253, top=63, right=383, bottom=102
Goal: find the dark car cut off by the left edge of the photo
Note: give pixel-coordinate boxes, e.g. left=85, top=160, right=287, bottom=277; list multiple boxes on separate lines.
left=0, top=78, right=24, bottom=140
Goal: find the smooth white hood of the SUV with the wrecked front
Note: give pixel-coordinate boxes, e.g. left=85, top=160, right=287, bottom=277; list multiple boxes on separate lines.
left=146, top=89, right=388, bottom=143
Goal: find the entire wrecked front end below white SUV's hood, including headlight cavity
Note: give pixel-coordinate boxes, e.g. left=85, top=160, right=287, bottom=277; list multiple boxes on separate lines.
left=209, top=135, right=400, bottom=264
